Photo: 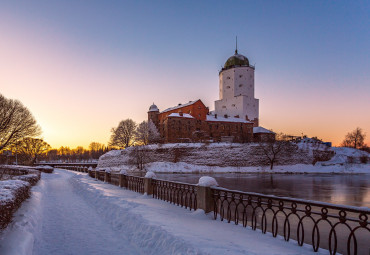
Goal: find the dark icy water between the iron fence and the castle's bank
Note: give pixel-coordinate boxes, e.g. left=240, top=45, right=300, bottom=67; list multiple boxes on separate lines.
left=156, top=173, right=370, bottom=208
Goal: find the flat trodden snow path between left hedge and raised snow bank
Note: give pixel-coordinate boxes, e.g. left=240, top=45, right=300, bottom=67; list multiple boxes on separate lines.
left=33, top=171, right=140, bottom=255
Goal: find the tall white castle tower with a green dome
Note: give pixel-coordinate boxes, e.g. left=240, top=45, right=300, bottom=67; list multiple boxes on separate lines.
left=214, top=49, right=259, bottom=127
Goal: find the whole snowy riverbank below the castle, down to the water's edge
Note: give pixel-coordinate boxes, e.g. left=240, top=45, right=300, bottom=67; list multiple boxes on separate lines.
left=98, top=143, right=370, bottom=174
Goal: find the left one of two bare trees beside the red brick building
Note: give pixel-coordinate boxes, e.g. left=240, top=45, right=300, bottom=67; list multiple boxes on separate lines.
left=109, top=119, right=136, bottom=148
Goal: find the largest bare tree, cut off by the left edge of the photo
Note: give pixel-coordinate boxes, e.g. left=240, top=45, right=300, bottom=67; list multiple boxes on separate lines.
left=0, top=94, right=41, bottom=150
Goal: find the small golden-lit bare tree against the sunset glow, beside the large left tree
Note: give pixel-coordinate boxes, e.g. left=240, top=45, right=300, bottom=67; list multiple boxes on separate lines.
left=15, top=137, right=51, bottom=164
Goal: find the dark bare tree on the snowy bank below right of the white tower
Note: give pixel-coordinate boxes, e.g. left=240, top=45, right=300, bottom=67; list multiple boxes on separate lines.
left=259, top=141, right=292, bottom=170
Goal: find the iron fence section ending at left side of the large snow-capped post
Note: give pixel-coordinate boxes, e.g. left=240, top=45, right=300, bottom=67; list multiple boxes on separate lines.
left=152, top=179, right=197, bottom=210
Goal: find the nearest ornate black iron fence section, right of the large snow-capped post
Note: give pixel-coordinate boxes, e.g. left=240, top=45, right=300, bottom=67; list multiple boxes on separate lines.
left=211, top=188, right=370, bottom=254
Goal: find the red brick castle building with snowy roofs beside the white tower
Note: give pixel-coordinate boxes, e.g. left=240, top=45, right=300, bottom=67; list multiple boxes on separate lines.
left=148, top=99, right=253, bottom=143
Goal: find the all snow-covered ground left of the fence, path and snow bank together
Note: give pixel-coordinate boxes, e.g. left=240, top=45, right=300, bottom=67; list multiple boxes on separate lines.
left=0, top=170, right=327, bottom=255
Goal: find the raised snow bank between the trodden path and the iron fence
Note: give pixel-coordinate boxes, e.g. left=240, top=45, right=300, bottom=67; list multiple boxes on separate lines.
left=71, top=171, right=327, bottom=255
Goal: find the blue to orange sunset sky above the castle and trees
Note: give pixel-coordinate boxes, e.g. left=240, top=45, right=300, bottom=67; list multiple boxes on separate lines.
left=0, top=0, right=370, bottom=148
